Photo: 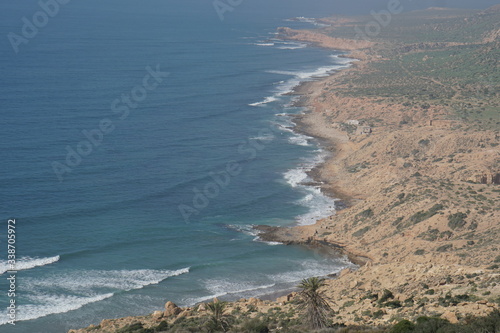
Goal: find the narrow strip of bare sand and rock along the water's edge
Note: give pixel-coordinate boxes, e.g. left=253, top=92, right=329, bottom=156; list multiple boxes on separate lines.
left=254, top=46, right=373, bottom=264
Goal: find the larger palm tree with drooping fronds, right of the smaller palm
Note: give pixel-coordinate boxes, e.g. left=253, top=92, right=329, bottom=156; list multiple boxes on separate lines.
left=297, top=277, right=332, bottom=329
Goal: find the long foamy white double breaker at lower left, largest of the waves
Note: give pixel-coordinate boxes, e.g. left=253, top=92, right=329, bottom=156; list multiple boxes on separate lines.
left=0, top=267, right=189, bottom=325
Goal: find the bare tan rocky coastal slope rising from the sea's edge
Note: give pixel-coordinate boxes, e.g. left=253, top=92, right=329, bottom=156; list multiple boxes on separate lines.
left=70, top=7, right=500, bottom=332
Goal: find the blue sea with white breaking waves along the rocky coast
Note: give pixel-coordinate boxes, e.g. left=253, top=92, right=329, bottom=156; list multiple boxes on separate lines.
left=0, top=0, right=358, bottom=333
